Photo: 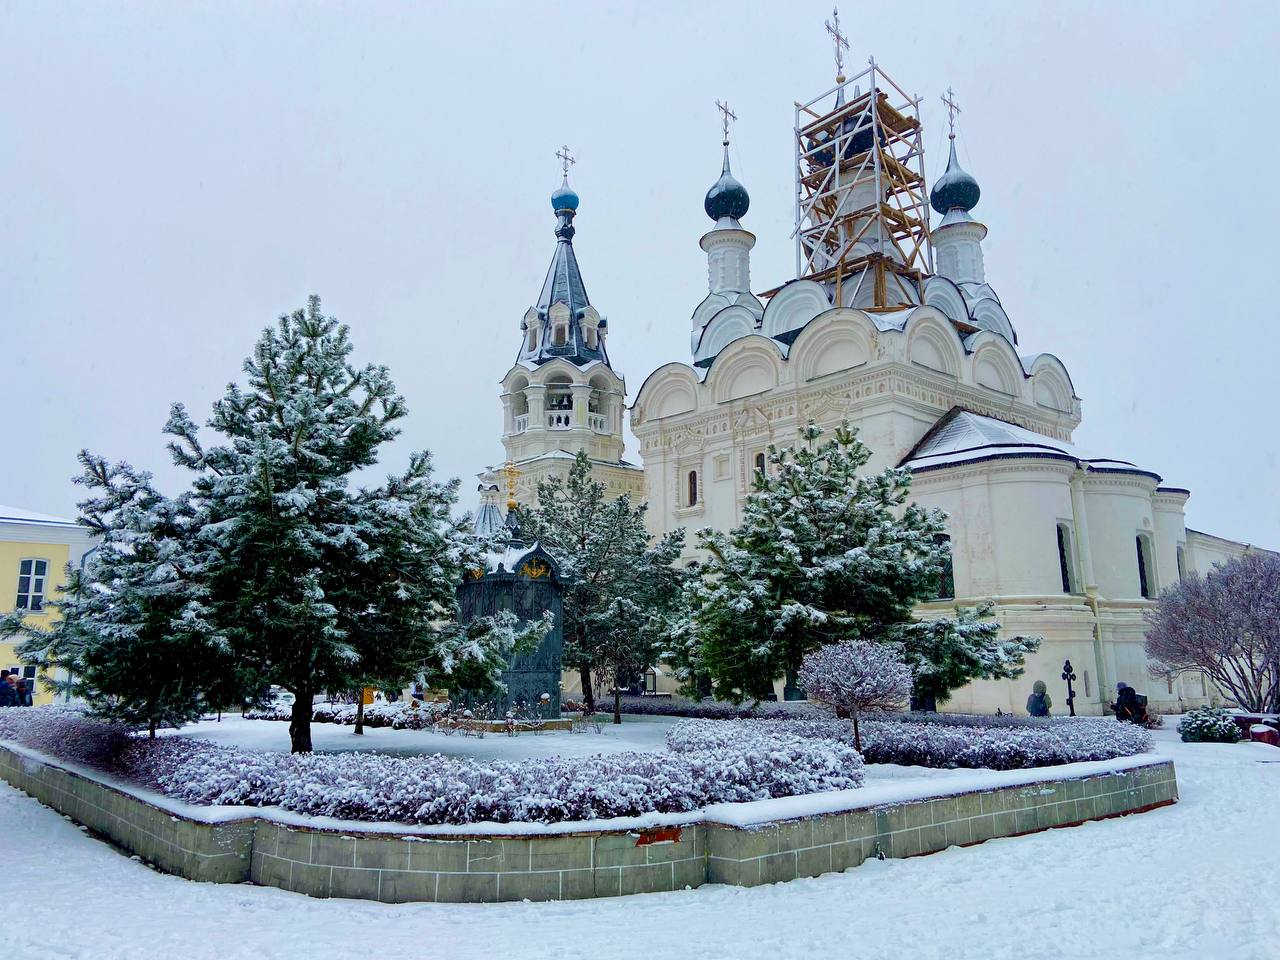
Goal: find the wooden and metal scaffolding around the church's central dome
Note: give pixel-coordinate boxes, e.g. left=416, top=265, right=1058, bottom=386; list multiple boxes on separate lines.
left=783, top=59, right=933, bottom=312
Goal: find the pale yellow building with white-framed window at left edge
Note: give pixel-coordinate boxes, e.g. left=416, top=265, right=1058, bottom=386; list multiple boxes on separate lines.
left=0, top=506, right=93, bottom=704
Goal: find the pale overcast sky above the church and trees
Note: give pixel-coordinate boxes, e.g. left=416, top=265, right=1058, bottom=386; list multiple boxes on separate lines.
left=0, top=0, right=1280, bottom=547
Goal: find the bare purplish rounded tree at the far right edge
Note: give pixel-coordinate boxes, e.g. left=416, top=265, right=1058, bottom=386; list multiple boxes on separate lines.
left=1147, top=550, right=1280, bottom=713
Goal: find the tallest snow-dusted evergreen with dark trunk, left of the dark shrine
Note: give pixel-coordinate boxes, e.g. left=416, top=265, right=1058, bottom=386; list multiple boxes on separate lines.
left=166, top=297, right=540, bottom=753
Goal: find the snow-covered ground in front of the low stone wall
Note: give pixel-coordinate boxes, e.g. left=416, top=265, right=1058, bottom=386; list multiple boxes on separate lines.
left=0, top=732, right=1280, bottom=960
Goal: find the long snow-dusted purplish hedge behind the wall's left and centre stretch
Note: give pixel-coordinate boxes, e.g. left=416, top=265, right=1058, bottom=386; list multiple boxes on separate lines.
left=0, top=708, right=863, bottom=824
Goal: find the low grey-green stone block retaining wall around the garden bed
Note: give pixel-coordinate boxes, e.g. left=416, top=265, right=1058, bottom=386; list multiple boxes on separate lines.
left=0, top=746, right=1178, bottom=902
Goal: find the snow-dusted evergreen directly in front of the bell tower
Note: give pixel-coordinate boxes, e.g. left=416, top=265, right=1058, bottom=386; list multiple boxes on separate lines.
left=518, top=451, right=685, bottom=709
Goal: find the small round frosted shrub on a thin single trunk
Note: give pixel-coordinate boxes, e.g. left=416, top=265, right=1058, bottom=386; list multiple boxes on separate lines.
left=800, top=640, right=911, bottom=753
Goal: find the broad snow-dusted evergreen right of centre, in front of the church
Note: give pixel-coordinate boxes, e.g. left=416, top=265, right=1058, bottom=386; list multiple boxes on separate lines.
left=685, top=422, right=1039, bottom=705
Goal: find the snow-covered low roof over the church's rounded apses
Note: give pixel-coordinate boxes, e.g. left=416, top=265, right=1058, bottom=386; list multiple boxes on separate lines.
left=900, top=407, right=1160, bottom=480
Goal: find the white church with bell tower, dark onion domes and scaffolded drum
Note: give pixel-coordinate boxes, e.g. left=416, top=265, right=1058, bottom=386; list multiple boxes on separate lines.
left=483, top=54, right=1269, bottom=714
